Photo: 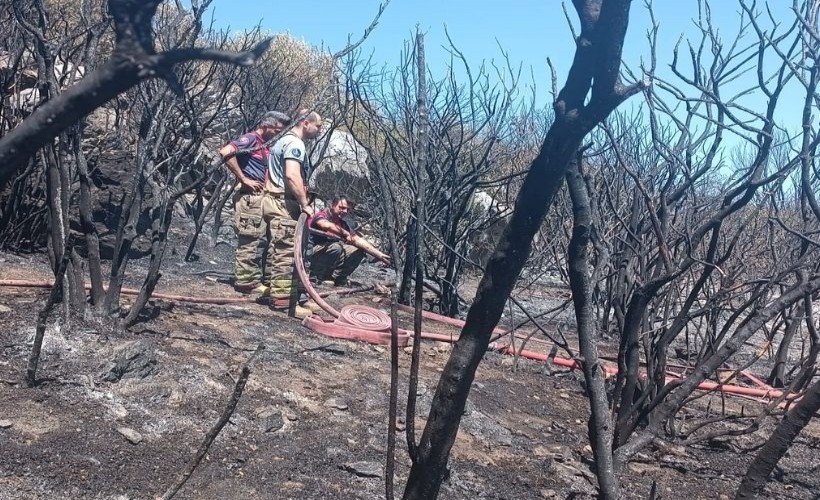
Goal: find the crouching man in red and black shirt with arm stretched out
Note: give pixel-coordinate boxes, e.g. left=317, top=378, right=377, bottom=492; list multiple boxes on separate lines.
left=309, top=196, right=390, bottom=286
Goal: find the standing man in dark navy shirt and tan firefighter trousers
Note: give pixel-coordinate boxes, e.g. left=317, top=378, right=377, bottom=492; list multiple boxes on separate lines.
left=219, top=111, right=290, bottom=293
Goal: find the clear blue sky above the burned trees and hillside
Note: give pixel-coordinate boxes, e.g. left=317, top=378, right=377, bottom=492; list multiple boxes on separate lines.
left=205, top=0, right=792, bottom=137
